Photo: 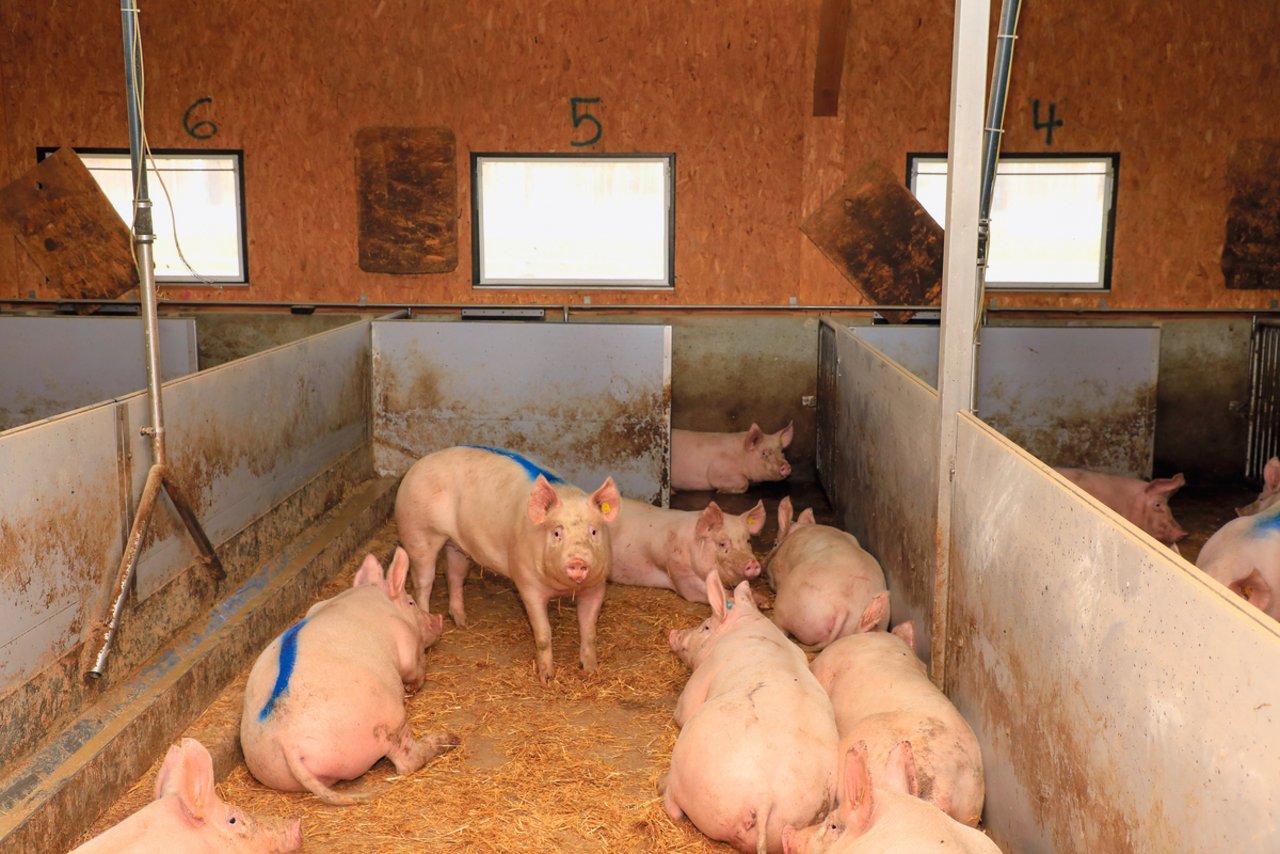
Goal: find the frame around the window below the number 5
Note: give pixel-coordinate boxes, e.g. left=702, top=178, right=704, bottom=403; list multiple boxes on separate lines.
left=471, top=151, right=676, bottom=291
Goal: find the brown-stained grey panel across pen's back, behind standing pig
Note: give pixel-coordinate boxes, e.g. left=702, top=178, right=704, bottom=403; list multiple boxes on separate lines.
left=374, top=320, right=671, bottom=504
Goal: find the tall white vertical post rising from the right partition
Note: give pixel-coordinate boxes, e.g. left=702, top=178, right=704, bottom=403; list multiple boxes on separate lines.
left=931, top=0, right=991, bottom=689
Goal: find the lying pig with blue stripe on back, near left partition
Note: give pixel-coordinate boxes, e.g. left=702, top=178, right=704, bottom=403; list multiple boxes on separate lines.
left=241, top=548, right=458, bottom=805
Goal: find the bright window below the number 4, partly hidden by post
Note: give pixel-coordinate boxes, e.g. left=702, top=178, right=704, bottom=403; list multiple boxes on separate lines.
left=908, top=154, right=1120, bottom=291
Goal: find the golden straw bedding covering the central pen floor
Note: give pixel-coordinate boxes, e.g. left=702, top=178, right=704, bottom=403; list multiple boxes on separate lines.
left=80, top=522, right=731, bottom=854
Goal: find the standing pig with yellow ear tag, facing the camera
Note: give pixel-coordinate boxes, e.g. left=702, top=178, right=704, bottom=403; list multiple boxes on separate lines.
left=396, top=446, right=622, bottom=686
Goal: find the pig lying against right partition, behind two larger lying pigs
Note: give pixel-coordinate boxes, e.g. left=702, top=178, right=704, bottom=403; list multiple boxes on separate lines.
left=765, top=497, right=890, bottom=649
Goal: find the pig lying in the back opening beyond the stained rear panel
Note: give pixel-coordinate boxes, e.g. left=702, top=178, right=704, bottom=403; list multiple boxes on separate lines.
left=671, top=423, right=792, bottom=493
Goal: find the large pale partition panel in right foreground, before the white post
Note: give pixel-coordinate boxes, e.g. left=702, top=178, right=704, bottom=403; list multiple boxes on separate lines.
left=950, top=416, right=1280, bottom=854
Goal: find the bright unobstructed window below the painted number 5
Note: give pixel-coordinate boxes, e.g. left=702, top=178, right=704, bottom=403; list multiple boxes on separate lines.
left=471, top=152, right=676, bottom=288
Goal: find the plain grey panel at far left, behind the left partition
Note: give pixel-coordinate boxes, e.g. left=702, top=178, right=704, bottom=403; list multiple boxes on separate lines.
left=0, top=316, right=197, bottom=430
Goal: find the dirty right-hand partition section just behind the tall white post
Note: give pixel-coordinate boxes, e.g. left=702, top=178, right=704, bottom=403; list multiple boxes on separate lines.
left=818, top=321, right=938, bottom=661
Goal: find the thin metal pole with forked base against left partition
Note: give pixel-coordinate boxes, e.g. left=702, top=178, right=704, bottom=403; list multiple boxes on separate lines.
left=86, top=0, right=227, bottom=681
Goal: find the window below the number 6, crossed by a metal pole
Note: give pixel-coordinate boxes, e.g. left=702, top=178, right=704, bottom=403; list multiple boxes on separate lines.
left=37, top=149, right=248, bottom=284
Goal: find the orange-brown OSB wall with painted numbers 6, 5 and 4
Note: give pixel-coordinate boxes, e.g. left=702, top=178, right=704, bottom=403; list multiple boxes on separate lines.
left=0, top=0, right=1280, bottom=310
